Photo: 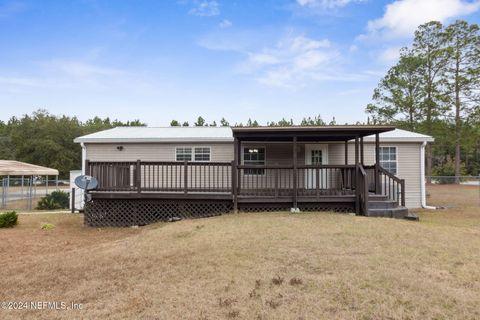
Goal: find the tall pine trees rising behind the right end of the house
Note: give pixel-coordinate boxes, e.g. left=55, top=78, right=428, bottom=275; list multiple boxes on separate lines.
left=366, top=20, right=480, bottom=176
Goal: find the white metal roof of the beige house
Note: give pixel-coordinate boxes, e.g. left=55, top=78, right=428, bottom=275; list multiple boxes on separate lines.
left=74, top=125, right=433, bottom=143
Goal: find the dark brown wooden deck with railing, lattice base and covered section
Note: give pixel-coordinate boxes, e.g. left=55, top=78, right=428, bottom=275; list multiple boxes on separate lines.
left=81, top=126, right=405, bottom=225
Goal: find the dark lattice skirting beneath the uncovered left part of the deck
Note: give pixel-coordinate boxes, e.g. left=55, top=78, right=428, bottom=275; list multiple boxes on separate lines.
left=84, top=199, right=233, bottom=227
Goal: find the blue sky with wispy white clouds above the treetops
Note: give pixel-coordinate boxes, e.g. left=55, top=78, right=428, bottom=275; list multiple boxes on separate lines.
left=0, top=0, right=480, bottom=126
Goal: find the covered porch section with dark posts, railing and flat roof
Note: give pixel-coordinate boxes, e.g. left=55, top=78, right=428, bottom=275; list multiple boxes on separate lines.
left=232, top=126, right=405, bottom=215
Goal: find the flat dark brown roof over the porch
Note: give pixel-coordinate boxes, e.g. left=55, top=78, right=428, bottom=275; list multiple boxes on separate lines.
left=232, top=125, right=395, bottom=141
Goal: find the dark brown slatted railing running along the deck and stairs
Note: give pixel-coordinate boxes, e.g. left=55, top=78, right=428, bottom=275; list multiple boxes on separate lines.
left=85, top=160, right=405, bottom=206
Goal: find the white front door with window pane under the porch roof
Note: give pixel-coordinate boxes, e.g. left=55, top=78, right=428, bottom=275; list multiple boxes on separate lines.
left=305, top=144, right=328, bottom=189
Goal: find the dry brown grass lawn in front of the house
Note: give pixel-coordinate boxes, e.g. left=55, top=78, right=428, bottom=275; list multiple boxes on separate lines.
left=0, top=186, right=480, bottom=319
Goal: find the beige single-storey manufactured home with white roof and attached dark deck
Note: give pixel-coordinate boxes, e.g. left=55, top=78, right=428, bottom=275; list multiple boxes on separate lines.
left=75, top=125, right=433, bottom=226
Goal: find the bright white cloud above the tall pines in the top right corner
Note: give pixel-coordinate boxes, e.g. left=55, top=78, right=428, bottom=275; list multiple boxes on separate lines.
left=366, top=0, right=480, bottom=38
